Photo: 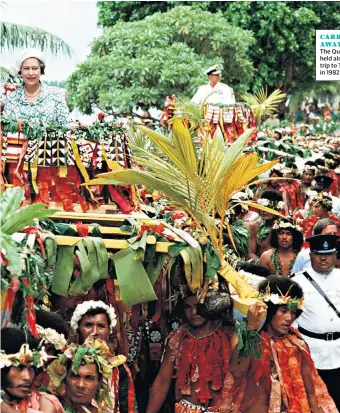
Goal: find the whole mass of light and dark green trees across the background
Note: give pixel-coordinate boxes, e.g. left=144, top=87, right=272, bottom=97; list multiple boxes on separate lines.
left=68, top=1, right=340, bottom=113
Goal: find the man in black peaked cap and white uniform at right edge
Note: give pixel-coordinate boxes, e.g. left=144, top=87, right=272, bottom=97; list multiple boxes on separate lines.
left=293, top=235, right=340, bottom=409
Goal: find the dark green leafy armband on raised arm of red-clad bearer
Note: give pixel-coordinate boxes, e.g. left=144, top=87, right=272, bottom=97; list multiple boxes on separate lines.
left=235, top=320, right=262, bottom=362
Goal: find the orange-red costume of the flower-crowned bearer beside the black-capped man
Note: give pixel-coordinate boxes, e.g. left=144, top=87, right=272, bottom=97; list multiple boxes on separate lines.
left=233, top=328, right=337, bottom=413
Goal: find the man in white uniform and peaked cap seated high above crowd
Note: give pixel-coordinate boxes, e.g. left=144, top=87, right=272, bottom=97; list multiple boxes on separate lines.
left=191, top=65, right=235, bottom=105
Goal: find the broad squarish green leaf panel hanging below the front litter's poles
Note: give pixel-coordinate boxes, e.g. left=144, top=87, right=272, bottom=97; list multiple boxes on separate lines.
left=112, top=248, right=157, bottom=305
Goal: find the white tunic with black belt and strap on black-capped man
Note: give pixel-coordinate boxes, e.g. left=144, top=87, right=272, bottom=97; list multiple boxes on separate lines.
left=293, top=268, right=340, bottom=370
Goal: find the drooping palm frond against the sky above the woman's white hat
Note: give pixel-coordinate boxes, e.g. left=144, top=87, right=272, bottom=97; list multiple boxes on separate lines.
left=0, top=22, right=72, bottom=56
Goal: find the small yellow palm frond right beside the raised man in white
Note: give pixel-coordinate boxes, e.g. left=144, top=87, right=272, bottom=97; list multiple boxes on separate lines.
left=242, top=88, right=287, bottom=126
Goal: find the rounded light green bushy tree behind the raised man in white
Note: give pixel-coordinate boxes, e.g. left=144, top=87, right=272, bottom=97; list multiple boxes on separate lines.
left=68, top=6, right=254, bottom=113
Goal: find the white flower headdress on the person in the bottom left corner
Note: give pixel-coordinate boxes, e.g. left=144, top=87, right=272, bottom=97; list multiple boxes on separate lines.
left=0, top=344, right=48, bottom=369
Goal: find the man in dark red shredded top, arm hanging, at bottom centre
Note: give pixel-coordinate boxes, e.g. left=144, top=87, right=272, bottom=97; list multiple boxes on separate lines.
left=146, top=296, right=233, bottom=413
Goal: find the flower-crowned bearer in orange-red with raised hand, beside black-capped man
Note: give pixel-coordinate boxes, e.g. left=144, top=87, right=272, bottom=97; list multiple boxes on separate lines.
left=230, top=276, right=338, bottom=413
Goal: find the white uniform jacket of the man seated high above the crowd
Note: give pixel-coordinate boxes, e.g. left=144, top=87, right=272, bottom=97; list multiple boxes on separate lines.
left=191, top=82, right=235, bottom=105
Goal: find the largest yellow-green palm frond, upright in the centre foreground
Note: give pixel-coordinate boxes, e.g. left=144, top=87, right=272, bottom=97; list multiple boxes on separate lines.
left=88, top=118, right=278, bottom=298
